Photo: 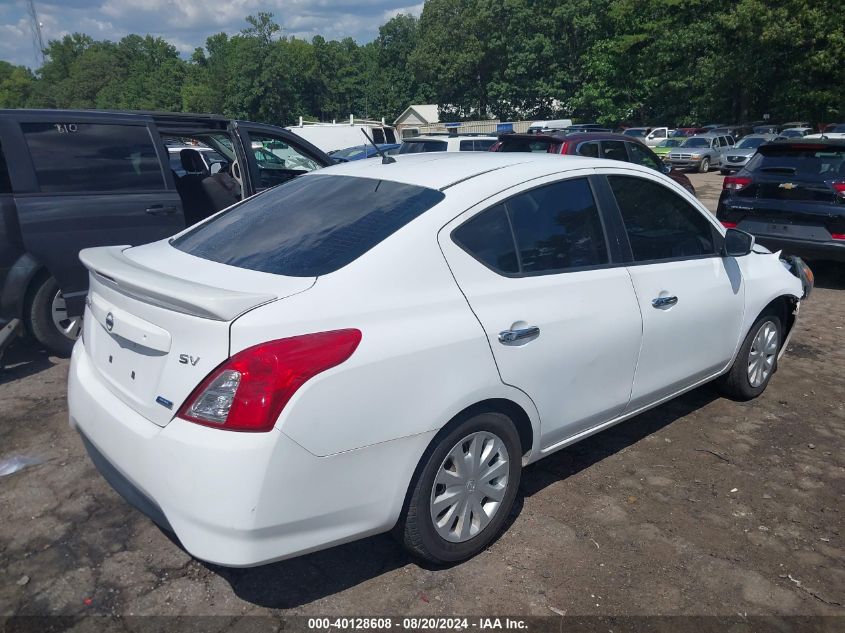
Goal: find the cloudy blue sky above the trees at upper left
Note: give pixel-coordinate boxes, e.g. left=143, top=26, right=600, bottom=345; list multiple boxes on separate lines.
left=0, top=0, right=422, bottom=68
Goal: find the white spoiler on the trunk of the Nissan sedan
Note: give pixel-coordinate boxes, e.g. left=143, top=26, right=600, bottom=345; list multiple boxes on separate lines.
left=79, top=246, right=278, bottom=321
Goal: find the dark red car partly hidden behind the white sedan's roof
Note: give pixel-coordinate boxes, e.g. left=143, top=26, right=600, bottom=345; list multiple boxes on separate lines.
left=490, top=132, right=695, bottom=195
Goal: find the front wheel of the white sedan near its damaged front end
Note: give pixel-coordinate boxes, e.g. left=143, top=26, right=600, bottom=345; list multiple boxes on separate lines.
left=717, top=314, right=783, bottom=401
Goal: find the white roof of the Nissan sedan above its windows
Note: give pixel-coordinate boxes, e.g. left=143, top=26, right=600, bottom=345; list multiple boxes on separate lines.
left=302, top=152, right=624, bottom=190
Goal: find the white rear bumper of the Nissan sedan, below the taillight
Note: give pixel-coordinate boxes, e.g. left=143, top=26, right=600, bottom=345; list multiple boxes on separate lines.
left=68, top=341, right=434, bottom=567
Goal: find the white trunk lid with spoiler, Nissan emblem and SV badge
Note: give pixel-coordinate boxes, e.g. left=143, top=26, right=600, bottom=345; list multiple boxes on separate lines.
left=80, top=242, right=315, bottom=426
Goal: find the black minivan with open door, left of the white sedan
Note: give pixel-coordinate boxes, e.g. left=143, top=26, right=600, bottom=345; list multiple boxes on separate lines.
left=0, top=110, right=332, bottom=355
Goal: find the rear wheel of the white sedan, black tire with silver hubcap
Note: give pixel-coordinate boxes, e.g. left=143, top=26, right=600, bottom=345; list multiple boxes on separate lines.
left=394, top=412, right=522, bottom=565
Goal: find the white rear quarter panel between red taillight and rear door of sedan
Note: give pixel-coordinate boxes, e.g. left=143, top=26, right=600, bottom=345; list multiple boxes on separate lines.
left=226, top=201, right=539, bottom=463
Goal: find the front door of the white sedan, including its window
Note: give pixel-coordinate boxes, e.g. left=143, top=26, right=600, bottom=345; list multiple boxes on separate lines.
left=607, top=172, right=745, bottom=411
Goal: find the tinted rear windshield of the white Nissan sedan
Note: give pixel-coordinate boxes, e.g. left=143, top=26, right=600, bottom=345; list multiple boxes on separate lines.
left=171, top=175, right=445, bottom=277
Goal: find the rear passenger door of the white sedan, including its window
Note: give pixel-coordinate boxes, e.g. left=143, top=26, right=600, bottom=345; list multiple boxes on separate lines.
left=439, top=170, right=642, bottom=449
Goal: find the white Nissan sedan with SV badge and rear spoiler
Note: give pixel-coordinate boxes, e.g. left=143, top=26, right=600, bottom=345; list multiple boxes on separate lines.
left=68, top=152, right=805, bottom=566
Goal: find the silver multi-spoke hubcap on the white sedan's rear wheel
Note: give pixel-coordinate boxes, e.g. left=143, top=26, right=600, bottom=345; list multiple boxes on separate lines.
left=430, top=431, right=510, bottom=543
